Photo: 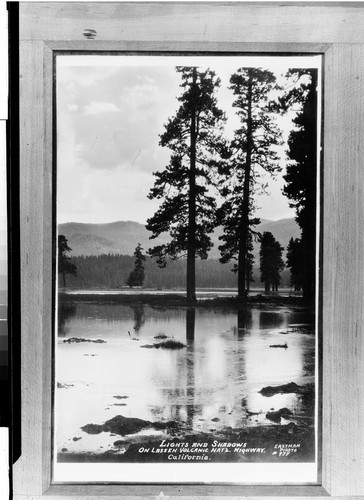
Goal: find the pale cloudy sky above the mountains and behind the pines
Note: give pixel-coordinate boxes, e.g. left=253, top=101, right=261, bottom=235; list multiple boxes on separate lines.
left=56, top=55, right=320, bottom=224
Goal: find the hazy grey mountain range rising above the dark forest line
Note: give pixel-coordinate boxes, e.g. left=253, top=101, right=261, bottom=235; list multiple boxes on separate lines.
left=58, top=218, right=300, bottom=259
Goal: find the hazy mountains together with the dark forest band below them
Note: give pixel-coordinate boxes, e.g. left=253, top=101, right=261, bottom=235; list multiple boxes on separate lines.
left=58, top=219, right=300, bottom=289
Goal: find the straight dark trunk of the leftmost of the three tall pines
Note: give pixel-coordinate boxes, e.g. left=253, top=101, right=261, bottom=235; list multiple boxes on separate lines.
left=187, top=68, right=197, bottom=303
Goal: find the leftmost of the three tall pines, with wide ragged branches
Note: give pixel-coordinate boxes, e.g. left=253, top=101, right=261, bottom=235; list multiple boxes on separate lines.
left=146, top=67, right=225, bottom=303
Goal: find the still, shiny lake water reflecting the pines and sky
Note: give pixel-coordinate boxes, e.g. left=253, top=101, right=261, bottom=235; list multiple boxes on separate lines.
left=55, top=301, right=315, bottom=453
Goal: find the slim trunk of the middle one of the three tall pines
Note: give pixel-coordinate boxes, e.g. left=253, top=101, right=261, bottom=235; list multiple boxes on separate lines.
left=238, top=75, right=253, bottom=299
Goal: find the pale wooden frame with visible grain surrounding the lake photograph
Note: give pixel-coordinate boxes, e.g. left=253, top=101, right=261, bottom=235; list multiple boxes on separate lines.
left=13, top=2, right=364, bottom=500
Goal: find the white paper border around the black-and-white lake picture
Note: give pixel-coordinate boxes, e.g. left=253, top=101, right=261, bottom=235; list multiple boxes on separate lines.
left=52, top=50, right=323, bottom=486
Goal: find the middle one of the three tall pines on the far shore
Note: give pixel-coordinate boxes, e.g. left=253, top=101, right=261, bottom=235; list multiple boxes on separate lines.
left=219, top=68, right=281, bottom=299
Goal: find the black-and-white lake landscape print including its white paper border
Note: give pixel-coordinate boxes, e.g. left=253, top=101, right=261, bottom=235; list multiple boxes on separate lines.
left=53, top=54, right=321, bottom=483
